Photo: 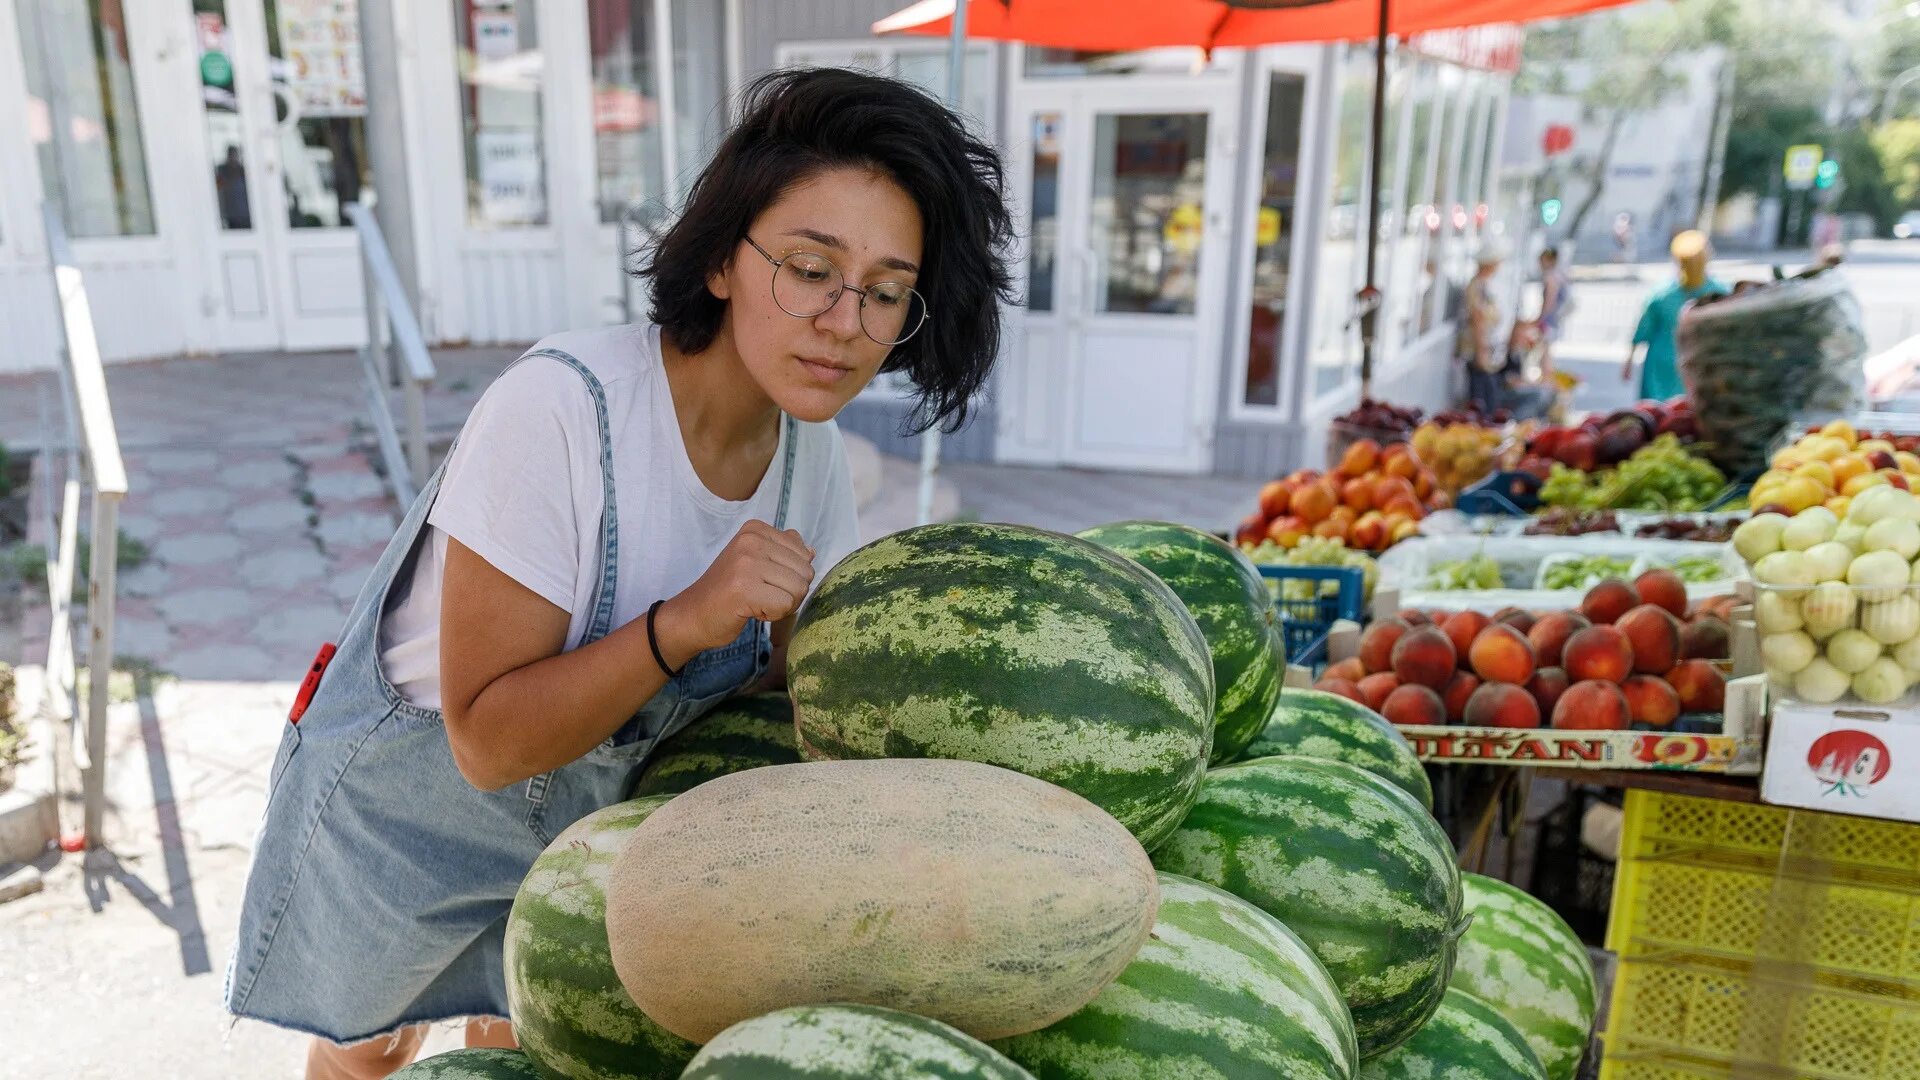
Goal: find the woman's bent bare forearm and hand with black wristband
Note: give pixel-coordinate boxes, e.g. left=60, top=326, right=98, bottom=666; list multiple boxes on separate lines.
left=440, top=521, right=814, bottom=790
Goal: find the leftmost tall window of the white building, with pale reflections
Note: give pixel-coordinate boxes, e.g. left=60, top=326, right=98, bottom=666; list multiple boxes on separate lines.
left=15, top=0, right=154, bottom=236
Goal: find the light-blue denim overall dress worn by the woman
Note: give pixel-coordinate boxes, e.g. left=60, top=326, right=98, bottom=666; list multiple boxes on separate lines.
left=227, top=350, right=799, bottom=1043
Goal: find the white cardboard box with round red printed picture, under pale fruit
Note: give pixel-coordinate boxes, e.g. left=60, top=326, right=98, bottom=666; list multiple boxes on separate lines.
left=1761, top=701, right=1920, bottom=821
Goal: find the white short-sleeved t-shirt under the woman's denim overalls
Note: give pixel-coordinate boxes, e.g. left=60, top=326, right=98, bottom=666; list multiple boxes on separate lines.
left=380, top=319, right=860, bottom=709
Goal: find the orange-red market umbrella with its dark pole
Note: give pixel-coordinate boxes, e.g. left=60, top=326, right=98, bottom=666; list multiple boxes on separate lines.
left=874, top=0, right=1634, bottom=394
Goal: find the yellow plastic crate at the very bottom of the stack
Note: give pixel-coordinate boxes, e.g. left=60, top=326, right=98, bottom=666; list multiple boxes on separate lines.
left=1599, top=957, right=1920, bottom=1080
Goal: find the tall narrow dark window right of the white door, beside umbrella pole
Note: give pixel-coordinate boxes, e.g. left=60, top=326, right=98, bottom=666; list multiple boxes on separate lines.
left=1242, top=71, right=1308, bottom=405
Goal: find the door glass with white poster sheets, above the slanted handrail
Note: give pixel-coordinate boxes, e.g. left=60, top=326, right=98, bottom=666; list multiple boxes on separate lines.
left=265, top=0, right=372, bottom=229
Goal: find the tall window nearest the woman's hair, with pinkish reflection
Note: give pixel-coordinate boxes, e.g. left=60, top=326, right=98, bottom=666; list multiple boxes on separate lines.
left=588, top=0, right=666, bottom=223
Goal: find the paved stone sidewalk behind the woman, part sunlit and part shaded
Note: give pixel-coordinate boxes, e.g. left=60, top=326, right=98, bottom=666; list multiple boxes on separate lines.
left=0, top=348, right=1256, bottom=1080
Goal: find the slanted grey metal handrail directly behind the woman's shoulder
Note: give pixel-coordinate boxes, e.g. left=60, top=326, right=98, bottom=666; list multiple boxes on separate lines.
left=346, top=204, right=434, bottom=509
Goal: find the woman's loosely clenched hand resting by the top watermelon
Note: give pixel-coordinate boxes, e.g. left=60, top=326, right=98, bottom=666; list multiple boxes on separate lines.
left=655, top=521, right=814, bottom=669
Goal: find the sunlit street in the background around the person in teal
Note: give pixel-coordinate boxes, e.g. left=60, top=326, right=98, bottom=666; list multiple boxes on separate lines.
left=1523, top=240, right=1920, bottom=409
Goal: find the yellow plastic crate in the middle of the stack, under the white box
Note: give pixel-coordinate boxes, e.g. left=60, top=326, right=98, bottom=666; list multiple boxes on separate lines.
left=1607, top=859, right=1920, bottom=990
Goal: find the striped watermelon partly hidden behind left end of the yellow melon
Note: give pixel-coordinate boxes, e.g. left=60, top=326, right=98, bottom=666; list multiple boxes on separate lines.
left=505, top=796, right=699, bottom=1080
